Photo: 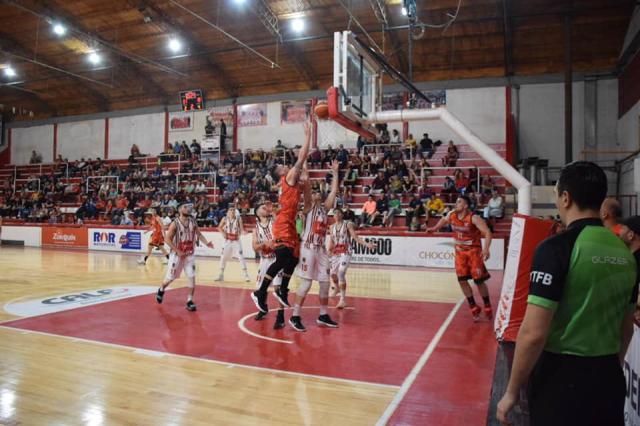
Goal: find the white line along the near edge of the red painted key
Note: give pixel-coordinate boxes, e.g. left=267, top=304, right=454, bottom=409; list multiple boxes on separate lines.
left=0, top=324, right=400, bottom=390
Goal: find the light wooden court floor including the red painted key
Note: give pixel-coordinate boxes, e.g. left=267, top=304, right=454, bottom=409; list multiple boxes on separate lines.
left=0, top=246, right=499, bottom=425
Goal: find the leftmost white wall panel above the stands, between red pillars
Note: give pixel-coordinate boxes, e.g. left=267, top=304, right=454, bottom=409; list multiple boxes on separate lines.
left=11, top=124, right=53, bottom=164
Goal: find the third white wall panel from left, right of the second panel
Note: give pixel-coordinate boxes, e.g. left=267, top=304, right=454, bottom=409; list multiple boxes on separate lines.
left=109, top=113, right=164, bottom=159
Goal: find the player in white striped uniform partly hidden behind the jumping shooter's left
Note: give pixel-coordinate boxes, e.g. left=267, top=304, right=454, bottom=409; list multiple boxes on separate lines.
left=253, top=204, right=284, bottom=330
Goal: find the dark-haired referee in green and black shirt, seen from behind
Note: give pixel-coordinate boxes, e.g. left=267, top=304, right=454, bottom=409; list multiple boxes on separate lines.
left=497, top=162, right=638, bottom=426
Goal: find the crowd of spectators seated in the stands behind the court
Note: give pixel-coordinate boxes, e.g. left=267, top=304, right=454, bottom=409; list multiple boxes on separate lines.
left=0, top=131, right=504, bottom=231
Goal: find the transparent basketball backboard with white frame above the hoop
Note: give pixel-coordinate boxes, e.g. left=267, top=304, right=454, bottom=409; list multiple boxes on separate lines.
left=333, top=31, right=382, bottom=122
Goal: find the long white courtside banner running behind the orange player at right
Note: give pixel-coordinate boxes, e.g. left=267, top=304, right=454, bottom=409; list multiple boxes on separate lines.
left=351, top=235, right=504, bottom=270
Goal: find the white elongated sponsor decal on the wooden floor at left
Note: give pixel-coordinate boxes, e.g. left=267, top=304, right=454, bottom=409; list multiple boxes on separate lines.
left=4, top=284, right=158, bottom=317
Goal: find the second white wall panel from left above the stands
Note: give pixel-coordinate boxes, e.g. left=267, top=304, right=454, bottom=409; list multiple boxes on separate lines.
left=58, top=119, right=105, bottom=161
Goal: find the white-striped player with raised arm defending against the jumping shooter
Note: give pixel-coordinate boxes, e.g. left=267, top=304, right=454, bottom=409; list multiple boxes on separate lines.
left=289, top=161, right=340, bottom=331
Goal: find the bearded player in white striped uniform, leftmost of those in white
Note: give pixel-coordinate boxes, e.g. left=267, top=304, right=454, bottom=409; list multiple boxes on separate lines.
left=156, top=203, right=213, bottom=312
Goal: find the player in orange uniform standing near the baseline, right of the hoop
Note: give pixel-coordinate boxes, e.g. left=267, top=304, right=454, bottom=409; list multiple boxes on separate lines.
left=427, top=195, right=493, bottom=321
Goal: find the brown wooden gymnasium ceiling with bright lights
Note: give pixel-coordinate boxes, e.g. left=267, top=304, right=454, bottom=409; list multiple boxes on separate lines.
left=0, top=0, right=635, bottom=120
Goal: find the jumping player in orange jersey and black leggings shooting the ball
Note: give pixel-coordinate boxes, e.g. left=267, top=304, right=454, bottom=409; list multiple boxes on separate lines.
left=251, top=123, right=311, bottom=313
